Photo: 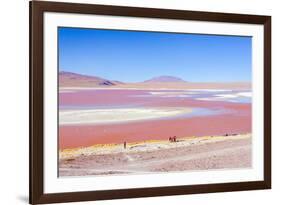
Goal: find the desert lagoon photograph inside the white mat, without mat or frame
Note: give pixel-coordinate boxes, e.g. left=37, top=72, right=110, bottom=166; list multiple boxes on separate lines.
left=57, top=27, right=252, bottom=177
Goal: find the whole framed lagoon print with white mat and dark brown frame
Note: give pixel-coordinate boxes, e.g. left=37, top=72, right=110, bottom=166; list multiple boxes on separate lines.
left=30, top=1, right=271, bottom=204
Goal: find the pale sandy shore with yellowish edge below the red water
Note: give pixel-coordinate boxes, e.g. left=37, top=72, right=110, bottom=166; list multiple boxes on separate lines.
left=59, top=134, right=249, bottom=176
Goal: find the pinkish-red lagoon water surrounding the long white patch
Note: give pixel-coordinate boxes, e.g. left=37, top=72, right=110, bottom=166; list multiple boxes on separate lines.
left=59, top=90, right=252, bottom=149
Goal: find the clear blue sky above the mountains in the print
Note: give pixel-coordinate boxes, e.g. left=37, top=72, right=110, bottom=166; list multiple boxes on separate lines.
left=58, top=28, right=252, bottom=82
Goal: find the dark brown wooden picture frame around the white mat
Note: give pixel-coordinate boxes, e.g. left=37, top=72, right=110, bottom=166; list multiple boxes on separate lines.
left=29, top=1, right=271, bottom=204
